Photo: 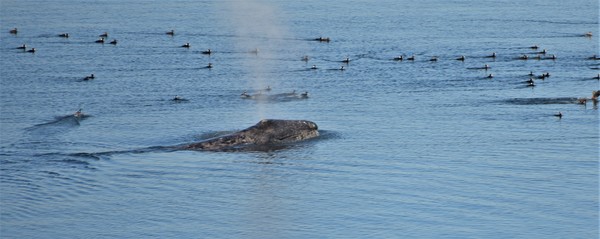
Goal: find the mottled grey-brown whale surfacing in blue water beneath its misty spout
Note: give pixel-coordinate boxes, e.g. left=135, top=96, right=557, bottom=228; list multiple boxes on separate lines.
left=180, top=119, right=319, bottom=151
